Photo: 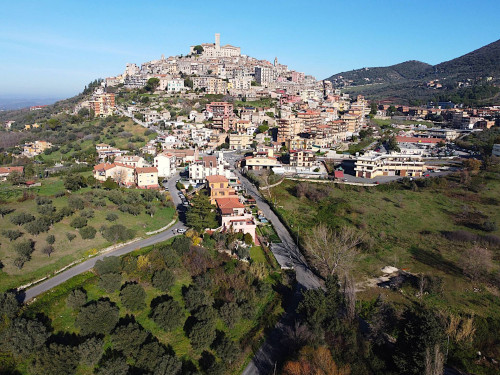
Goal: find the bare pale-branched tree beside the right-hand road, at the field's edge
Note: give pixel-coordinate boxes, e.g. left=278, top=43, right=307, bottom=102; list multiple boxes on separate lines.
left=305, top=224, right=363, bottom=277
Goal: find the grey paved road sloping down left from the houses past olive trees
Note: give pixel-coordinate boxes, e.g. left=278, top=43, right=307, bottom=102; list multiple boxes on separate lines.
left=18, top=175, right=186, bottom=302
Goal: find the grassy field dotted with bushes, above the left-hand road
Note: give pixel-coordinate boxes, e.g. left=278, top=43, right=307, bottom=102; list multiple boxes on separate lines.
left=0, top=177, right=175, bottom=291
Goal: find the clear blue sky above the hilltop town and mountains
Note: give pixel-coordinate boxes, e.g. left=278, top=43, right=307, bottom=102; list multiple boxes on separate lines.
left=0, top=0, right=500, bottom=98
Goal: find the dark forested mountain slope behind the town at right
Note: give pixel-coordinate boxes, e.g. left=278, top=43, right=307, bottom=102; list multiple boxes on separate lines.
left=327, top=40, right=500, bottom=105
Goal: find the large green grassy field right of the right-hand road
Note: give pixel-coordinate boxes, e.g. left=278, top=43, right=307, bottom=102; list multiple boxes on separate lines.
left=273, top=166, right=500, bottom=317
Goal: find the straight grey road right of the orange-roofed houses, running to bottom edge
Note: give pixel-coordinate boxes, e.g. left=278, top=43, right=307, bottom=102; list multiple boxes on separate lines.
left=225, top=154, right=321, bottom=375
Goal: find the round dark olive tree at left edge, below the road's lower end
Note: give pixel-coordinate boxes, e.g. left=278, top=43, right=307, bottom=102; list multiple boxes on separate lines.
left=0, top=318, right=50, bottom=356
